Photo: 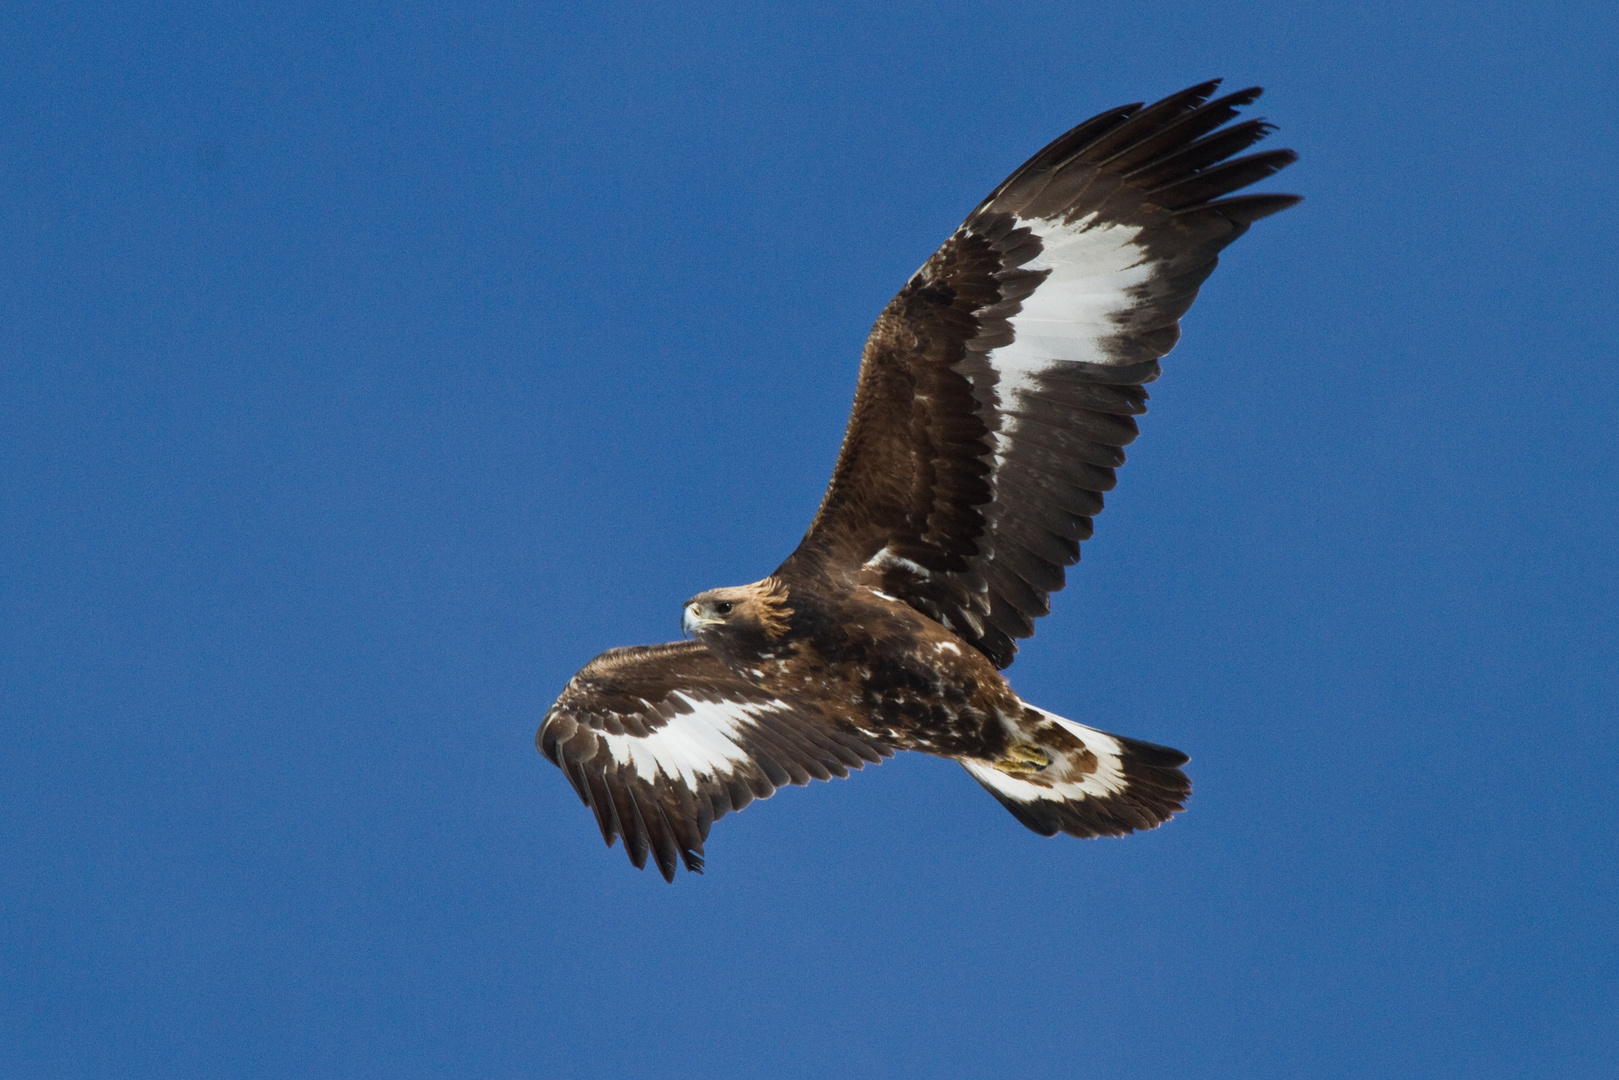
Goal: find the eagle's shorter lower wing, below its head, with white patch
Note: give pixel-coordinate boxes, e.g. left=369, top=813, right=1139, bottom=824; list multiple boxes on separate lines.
left=534, top=641, right=894, bottom=881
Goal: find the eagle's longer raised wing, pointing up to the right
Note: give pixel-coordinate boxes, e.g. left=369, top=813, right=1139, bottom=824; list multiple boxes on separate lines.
left=779, top=81, right=1298, bottom=667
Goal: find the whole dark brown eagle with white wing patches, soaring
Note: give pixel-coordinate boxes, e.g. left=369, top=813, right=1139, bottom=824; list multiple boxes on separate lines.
left=534, top=81, right=1298, bottom=881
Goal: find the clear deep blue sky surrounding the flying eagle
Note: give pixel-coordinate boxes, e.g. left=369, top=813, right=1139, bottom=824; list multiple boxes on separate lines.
left=0, top=0, right=1619, bottom=1080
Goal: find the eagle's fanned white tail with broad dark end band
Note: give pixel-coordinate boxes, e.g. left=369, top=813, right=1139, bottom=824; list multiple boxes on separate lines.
left=960, top=706, right=1192, bottom=837
